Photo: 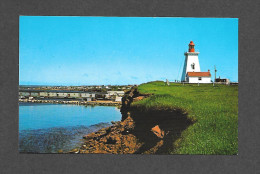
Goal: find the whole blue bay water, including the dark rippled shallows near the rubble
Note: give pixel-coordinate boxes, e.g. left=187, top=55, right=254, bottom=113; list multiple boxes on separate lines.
left=19, top=103, right=121, bottom=153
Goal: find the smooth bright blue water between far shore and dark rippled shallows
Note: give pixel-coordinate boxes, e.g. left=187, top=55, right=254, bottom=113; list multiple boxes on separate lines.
left=19, top=103, right=121, bottom=130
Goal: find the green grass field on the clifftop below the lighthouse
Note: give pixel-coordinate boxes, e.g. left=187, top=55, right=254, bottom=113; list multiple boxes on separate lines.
left=132, top=81, right=238, bottom=155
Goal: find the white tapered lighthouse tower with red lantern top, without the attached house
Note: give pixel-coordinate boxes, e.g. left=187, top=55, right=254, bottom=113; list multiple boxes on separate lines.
left=181, top=41, right=200, bottom=82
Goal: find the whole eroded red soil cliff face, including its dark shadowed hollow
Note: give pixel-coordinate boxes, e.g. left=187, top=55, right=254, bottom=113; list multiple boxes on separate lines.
left=71, top=87, right=191, bottom=154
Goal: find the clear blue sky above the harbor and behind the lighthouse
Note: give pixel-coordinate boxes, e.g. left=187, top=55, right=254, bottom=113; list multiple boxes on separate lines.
left=19, top=16, right=238, bottom=85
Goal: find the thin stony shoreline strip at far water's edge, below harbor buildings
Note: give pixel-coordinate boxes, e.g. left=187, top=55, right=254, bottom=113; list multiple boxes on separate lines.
left=19, top=99, right=122, bottom=106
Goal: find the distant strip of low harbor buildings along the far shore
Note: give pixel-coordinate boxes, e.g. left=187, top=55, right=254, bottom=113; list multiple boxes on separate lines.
left=19, top=87, right=125, bottom=106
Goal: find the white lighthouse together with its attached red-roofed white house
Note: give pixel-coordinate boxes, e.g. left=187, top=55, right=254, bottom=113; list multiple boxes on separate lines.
left=181, top=41, right=211, bottom=83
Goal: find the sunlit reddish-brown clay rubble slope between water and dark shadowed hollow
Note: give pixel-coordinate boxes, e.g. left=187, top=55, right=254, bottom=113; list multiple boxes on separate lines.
left=72, top=116, right=145, bottom=154
